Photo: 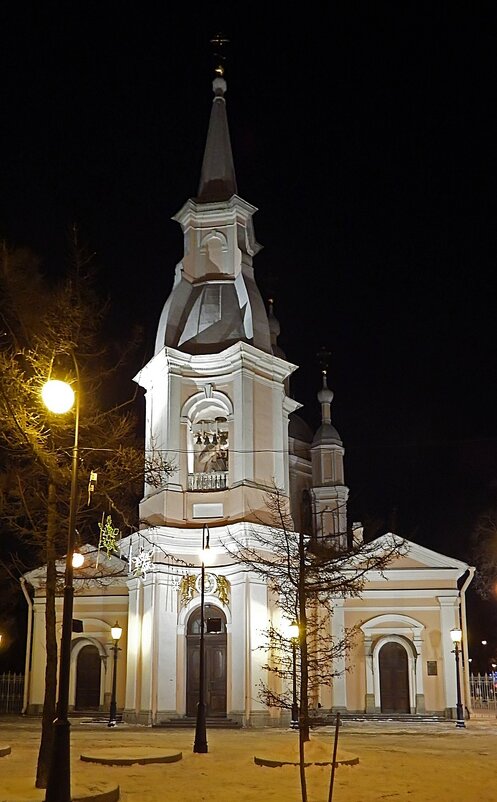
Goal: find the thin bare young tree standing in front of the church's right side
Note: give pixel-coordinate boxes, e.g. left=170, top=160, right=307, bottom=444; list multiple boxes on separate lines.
left=225, top=488, right=405, bottom=802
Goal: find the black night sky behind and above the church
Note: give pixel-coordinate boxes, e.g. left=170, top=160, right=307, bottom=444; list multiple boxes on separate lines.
left=0, top=0, right=497, bottom=660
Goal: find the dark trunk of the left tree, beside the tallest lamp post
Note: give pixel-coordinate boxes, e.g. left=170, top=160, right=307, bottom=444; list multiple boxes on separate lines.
left=35, top=483, right=58, bottom=788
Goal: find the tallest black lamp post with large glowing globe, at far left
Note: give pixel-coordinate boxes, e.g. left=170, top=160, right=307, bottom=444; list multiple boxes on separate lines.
left=42, top=366, right=80, bottom=802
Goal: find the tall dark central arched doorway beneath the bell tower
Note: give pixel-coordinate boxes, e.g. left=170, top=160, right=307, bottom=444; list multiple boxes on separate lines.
left=186, top=604, right=226, bottom=717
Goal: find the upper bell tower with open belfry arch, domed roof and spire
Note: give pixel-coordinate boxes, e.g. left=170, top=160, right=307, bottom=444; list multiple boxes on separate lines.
left=135, top=68, right=301, bottom=527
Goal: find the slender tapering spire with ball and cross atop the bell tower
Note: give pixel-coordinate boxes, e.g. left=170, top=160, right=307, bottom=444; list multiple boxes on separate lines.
left=196, top=33, right=237, bottom=203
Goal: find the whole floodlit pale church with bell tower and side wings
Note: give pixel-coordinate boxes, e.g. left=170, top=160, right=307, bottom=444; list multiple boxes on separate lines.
left=25, top=64, right=473, bottom=727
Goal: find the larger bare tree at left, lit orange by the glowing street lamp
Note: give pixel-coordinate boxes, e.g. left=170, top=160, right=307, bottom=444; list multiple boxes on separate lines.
left=0, top=232, right=172, bottom=787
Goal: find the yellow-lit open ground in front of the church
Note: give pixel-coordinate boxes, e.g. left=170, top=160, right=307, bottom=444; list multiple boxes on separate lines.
left=0, top=717, right=497, bottom=802
